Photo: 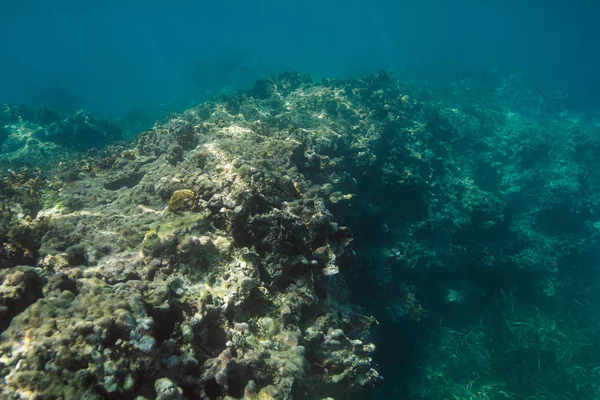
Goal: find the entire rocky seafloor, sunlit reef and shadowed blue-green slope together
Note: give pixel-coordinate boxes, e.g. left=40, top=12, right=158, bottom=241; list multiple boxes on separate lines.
left=0, top=72, right=600, bottom=400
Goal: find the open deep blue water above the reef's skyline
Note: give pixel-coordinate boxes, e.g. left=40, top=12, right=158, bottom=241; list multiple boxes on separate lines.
left=0, top=0, right=600, bottom=114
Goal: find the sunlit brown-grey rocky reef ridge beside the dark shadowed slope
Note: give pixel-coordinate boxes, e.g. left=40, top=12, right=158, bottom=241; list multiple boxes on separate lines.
left=0, top=75, right=382, bottom=399
